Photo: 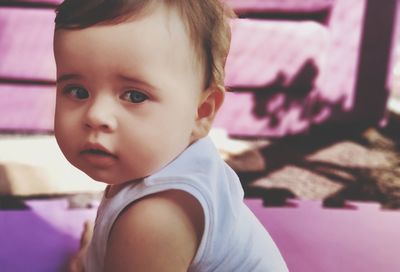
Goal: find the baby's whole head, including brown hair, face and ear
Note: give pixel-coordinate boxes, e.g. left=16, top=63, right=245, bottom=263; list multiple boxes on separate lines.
left=54, top=0, right=231, bottom=184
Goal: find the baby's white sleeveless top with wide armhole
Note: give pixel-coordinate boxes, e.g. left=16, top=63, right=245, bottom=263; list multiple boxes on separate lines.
left=85, top=137, right=288, bottom=272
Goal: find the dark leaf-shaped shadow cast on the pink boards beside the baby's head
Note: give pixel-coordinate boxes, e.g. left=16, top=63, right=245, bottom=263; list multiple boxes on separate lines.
left=234, top=59, right=351, bottom=132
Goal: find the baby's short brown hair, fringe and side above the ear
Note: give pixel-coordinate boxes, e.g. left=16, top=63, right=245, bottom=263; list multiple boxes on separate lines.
left=55, top=0, right=234, bottom=90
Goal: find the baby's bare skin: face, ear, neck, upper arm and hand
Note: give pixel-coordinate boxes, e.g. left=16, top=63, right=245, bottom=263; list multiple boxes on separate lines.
left=54, top=4, right=224, bottom=272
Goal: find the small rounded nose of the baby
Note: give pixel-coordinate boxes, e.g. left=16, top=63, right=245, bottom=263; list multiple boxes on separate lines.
left=85, top=98, right=117, bottom=132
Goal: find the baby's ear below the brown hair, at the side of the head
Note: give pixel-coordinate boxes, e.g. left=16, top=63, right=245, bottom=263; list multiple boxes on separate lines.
left=192, top=85, right=225, bottom=141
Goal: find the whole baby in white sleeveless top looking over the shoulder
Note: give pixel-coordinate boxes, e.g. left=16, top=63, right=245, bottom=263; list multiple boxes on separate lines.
left=54, top=0, right=287, bottom=272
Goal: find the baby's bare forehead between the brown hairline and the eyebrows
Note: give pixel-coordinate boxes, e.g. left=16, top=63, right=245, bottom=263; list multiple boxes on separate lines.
left=54, top=2, right=204, bottom=94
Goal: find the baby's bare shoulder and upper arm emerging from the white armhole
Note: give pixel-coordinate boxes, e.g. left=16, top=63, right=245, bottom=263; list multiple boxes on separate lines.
left=105, top=190, right=204, bottom=272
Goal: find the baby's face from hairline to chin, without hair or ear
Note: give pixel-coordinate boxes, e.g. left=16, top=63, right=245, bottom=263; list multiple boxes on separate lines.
left=54, top=5, right=203, bottom=184
